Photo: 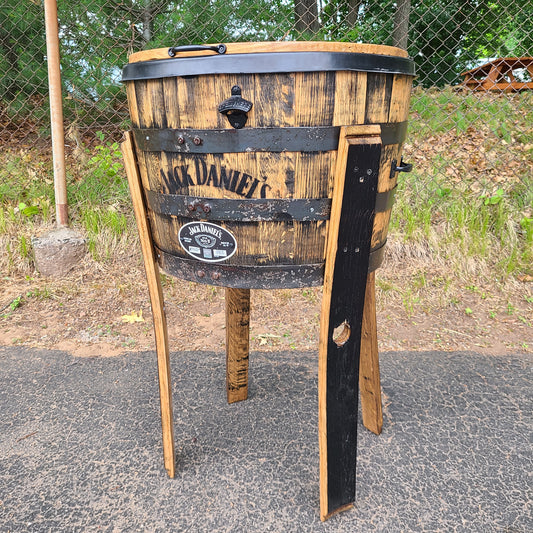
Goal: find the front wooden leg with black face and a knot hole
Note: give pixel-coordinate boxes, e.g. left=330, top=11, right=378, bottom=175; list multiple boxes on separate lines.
left=318, top=126, right=381, bottom=520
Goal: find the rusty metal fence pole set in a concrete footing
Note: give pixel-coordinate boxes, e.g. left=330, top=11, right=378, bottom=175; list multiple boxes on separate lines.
left=44, top=0, right=68, bottom=227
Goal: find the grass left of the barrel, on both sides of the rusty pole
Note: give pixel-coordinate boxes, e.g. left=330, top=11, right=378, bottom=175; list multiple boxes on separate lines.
left=0, top=134, right=136, bottom=273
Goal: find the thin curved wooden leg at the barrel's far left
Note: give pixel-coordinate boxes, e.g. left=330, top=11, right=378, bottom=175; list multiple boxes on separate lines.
left=121, top=132, right=175, bottom=478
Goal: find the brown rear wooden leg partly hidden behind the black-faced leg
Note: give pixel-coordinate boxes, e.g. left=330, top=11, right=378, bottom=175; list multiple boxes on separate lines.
left=359, top=272, right=383, bottom=435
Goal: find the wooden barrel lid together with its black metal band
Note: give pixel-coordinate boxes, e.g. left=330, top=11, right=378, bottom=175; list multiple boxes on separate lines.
left=122, top=41, right=415, bottom=81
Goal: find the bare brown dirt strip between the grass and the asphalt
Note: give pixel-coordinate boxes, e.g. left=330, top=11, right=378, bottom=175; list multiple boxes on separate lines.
left=0, top=242, right=533, bottom=357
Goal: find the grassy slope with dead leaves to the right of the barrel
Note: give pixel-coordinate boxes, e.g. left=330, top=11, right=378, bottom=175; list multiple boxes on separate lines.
left=391, top=89, right=533, bottom=276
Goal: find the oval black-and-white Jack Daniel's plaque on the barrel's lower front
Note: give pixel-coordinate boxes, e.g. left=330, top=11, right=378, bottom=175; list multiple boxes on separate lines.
left=178, top=222, right=237, bottom=263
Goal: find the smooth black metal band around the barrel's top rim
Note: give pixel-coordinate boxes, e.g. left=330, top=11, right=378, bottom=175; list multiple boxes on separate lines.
left=121, top=51, right=415, bottom=82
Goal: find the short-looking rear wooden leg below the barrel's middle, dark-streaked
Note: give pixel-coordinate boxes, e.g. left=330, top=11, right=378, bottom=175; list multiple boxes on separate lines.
left=226, top=288, right=250, bottom=403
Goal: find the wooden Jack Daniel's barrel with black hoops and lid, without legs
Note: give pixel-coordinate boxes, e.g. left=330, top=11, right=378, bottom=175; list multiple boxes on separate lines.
left=123, top=42, right=414, bottom=288
